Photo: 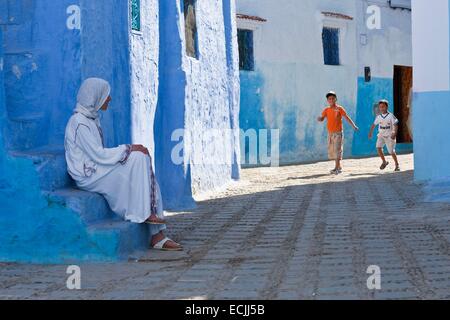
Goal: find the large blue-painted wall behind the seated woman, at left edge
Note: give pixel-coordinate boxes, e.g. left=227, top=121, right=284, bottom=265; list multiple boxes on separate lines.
left=0, top=0, right=136, bottom=263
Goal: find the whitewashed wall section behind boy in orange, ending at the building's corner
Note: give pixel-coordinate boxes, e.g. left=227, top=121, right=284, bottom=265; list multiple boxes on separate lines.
left=237, top=0, right=358, bottom=162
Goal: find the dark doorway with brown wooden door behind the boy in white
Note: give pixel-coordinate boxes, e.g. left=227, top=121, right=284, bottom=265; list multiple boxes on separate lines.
left=394, top=66, right=413, bottom=143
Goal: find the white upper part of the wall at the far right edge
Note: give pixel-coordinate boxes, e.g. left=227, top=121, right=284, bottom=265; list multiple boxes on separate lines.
left=412, top=0, right=450, bottom=92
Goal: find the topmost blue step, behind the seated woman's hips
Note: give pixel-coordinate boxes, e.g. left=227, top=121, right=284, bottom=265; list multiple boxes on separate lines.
left=10, top=147, right=74, bottom=191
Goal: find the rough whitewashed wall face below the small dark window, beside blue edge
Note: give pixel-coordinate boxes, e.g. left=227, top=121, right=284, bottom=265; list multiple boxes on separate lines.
left=180, top=0, right=239, bottom=195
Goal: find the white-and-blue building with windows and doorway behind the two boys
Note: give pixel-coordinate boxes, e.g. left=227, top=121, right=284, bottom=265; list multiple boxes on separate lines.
left=237, top=0, right=413, bottom=164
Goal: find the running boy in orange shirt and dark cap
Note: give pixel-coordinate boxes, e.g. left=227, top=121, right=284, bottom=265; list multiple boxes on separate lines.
left=317, top=91, right=359, bottom=174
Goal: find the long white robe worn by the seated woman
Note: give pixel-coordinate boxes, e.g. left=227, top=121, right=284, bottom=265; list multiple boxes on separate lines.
left=65, top=113, right=165, bottom=230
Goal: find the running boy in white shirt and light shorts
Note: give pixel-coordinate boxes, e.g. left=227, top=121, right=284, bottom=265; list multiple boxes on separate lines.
left=369, top=100, right=400, bottom=171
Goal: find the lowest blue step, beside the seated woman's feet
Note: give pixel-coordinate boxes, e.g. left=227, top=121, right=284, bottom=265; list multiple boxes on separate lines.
left=88, top=221, right=150, bottom=260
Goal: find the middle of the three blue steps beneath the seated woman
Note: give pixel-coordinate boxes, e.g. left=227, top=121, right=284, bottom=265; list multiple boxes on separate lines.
left=44, top=188, right=116, bottom=225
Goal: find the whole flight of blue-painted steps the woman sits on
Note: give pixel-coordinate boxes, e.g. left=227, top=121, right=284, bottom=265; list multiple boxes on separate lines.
left=10, top=148, right=149, bottom=261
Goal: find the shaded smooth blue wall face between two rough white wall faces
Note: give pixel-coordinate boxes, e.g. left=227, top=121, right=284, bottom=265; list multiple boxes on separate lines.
left=154, top=1, right=195, bottom=210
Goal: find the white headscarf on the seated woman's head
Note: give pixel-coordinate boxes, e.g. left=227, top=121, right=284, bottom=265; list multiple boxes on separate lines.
left=75, top=78, right=111, bottom=120
